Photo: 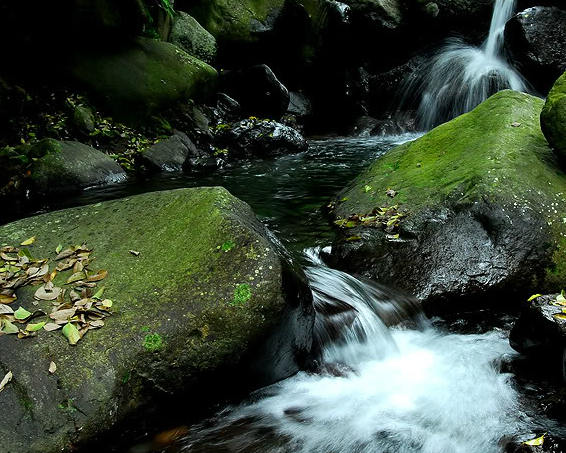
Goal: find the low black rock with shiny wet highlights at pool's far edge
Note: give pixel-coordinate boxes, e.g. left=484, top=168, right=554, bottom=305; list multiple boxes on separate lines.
left=215, top=119, right=308, bottom=157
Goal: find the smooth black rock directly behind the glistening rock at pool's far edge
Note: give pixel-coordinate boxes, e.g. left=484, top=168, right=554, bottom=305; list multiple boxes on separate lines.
left=220, top=65, right=289, bottom=119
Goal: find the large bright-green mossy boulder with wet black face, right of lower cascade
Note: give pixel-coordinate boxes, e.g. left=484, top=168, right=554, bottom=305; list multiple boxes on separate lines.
left=331, top=91, right=566, bottom=313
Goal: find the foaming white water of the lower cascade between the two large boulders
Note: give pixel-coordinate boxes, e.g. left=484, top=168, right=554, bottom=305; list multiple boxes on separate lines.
left=182, top=250, right=540, bottom=453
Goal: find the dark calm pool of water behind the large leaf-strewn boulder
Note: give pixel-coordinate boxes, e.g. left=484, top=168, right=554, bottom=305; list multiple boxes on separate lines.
left=0, top=134, right=416, bottom=252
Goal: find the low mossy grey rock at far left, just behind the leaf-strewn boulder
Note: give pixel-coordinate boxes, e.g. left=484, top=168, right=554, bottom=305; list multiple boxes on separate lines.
left=26, top=139, right=126, bottom=195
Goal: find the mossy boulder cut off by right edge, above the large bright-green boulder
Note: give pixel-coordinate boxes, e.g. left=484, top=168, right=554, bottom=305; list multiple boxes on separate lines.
left=540, top=73, right=566, bottom=159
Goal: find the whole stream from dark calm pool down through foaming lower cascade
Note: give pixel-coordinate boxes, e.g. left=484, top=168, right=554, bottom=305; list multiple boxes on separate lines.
left=8, top=134, right=566, bottom=453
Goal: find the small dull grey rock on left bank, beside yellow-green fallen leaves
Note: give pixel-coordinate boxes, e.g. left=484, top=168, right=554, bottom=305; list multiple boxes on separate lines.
left=137, top=135, right=194, bottom=171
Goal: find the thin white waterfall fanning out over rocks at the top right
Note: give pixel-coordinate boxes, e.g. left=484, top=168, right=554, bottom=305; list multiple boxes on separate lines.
left=405, top=0, right=527, bottom=130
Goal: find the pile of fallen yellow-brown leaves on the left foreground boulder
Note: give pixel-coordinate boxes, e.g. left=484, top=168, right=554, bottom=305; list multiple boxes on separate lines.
left=0, top=242, right=112, bottom=345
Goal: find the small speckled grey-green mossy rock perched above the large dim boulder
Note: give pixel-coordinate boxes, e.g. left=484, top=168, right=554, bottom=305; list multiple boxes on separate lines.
left=169, top=11, right=217, bottom=64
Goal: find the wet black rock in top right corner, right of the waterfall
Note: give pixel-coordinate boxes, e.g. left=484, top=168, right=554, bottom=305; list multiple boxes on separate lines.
left=505, top=6, right=566, bottom=94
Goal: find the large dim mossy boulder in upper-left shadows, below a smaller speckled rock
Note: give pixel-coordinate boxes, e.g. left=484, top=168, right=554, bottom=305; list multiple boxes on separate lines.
left=68, top=37, right=218, bottom=124
